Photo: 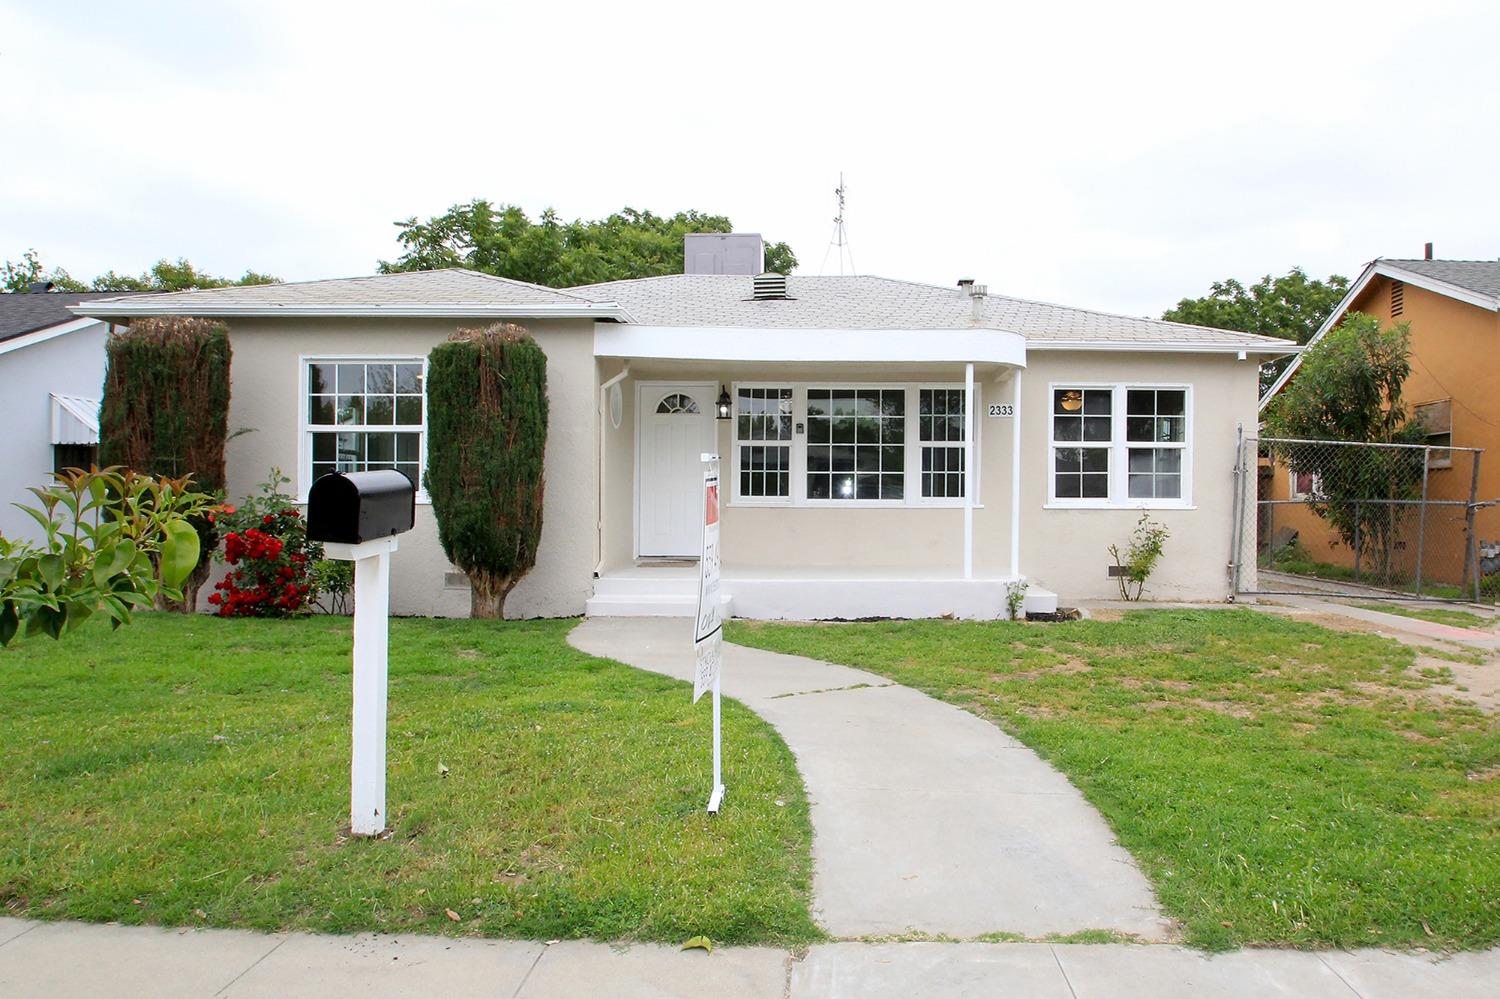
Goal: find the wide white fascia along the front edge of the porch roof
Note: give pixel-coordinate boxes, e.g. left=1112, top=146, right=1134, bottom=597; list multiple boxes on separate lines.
left=594, top=323, right=1026, bottom=368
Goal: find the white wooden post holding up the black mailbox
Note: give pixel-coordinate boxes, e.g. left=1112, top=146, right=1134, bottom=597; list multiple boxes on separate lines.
left=323, top=537, right=396, bottom=836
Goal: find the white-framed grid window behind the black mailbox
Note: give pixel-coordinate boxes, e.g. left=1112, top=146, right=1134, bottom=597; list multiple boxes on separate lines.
left=299, top=357, right=428, bottom=501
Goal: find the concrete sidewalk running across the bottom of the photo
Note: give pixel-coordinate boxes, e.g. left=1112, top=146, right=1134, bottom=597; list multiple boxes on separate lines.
left=0, top=918, right=1500, bottom=999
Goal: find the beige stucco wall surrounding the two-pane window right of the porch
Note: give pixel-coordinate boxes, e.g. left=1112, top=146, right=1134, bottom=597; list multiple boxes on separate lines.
left=1022, top=351, right=1259, bottom=605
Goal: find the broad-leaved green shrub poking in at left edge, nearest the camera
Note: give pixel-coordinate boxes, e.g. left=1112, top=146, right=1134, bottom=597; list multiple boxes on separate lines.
left=0, top=468, right=216, bottom=645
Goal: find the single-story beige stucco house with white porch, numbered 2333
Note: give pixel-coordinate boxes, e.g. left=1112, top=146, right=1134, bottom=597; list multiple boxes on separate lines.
left=77, top=247, right=1289, bottom=618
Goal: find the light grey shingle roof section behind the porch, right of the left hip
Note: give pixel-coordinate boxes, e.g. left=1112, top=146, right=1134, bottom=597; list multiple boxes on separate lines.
left=569, top=275, right=1289, bottom=348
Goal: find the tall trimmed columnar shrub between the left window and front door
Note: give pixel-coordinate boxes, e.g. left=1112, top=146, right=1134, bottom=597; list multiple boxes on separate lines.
left=425, top=324, right=548, bottom=618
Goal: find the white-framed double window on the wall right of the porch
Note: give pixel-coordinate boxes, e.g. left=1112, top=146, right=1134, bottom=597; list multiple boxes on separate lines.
left=1047, top=384, right=1193, bottom=507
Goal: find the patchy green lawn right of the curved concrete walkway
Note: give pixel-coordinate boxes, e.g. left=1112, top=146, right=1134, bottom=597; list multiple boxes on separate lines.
left=729, top=611, right=1500, bottom=948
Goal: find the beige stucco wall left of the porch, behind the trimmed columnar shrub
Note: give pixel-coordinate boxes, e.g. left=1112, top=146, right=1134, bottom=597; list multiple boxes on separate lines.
left=219, top=320, right=599, bottom=618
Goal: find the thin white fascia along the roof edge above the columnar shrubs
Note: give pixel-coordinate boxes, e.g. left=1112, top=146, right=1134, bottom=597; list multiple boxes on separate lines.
left=69, top=300, right=630, bottom=323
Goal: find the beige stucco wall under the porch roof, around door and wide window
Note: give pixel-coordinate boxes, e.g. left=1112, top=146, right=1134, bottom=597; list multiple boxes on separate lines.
left=600, top=360, right=1013, bottom=575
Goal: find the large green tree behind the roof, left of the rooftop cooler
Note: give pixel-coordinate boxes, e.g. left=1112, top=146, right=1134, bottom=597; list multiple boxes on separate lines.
left=380, top=198, right=797, bottom=288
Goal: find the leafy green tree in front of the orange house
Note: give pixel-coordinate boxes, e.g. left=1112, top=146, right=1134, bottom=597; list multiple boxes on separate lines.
left=1266, top=312, right=1424, bottom=576
